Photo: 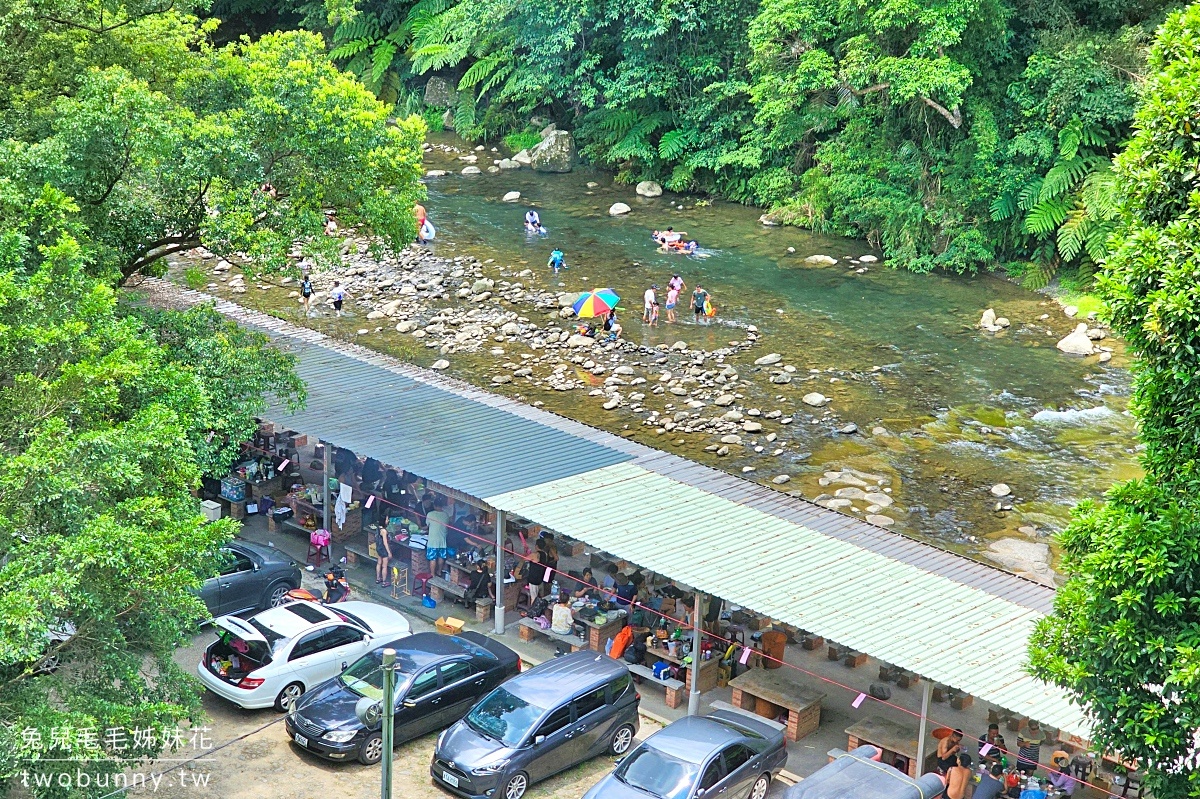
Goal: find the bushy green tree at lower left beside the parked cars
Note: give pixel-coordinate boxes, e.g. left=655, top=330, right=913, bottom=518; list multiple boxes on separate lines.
left=0, top=177, right=304, bottom=797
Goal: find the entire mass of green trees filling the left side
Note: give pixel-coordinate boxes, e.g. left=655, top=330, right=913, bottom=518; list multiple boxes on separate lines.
left=0, top=0, right=425, bottom=799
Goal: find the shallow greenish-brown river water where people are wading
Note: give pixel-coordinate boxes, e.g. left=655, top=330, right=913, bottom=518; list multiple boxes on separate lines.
left=174, top=138, right=1139, bottom=573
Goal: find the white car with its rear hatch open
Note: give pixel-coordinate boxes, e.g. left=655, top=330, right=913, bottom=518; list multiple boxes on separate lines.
left=196, top=601, right=410, bottom=710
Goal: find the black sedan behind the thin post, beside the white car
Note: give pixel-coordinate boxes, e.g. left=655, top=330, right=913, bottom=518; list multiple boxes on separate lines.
left=284, top=631, right=521, bottom=765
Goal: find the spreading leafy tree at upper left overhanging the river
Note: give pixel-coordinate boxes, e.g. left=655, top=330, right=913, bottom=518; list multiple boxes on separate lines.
left=0, top=0, right=425, bottom=283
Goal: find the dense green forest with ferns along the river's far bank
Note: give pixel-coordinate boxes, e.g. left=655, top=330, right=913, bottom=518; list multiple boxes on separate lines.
left=255, top=0, right=1174, bottom=279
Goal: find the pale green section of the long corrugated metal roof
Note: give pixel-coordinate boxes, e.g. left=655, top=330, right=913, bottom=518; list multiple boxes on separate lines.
left=484, top=463, right=1090, bottom=738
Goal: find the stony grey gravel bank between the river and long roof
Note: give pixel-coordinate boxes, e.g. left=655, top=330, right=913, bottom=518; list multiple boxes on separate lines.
left=185, top=235, right=905, bottom=535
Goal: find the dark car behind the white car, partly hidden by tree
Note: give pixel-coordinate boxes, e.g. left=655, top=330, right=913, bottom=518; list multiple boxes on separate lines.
left=199, top=541, right=300, bottom=615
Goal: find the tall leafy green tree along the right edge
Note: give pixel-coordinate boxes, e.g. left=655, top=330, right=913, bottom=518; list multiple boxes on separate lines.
left=1031, top=5, right=1200, bottom=799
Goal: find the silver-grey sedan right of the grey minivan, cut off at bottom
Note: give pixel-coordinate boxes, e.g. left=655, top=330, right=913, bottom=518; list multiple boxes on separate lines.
left=583, top=710, right=787, bottom=799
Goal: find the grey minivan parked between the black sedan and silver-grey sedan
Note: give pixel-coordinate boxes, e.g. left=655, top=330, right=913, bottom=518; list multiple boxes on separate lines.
left=430, top=651, right=641, bottom=799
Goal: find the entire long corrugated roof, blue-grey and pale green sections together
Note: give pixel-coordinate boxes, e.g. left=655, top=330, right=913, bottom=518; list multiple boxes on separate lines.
left=148, top=281, right=1090, bottom=738
